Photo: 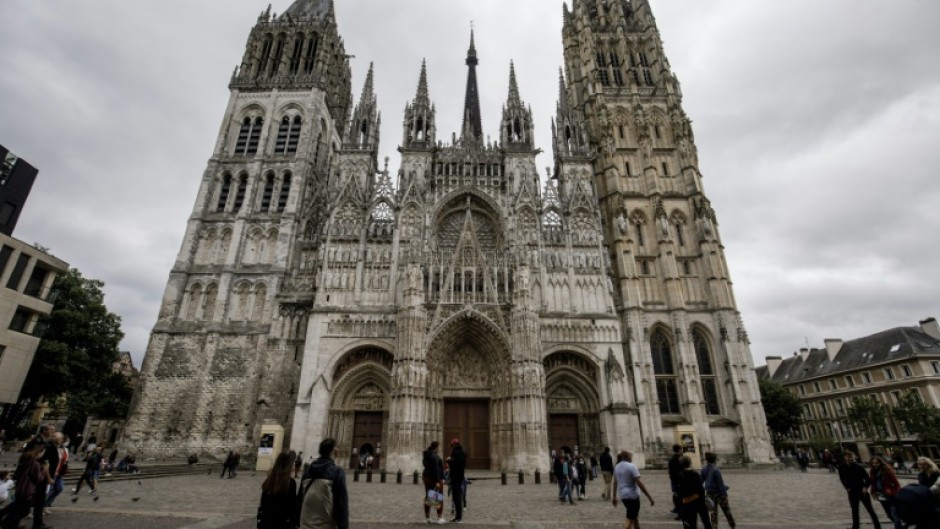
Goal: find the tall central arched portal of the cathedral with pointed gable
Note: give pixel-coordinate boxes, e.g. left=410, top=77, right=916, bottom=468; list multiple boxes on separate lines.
left=428, top=309, right=512, bottom=469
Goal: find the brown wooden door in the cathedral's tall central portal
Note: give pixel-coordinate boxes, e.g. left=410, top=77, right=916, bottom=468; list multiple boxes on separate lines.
left=441, top=400, right=490, bottom=469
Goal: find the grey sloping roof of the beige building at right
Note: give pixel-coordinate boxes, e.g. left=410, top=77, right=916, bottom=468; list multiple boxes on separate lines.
left=756, top=327, right=940, bottom=384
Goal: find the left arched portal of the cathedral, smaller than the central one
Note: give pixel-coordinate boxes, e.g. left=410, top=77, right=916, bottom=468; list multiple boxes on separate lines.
left=327, top=347, right=393, bottom=468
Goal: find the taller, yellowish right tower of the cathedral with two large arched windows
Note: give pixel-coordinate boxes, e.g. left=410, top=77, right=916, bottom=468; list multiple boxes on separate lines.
left=555, top=0, right=772, bottom=463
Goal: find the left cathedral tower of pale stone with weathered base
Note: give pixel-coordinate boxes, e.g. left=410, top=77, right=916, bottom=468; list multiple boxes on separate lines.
left=124, top=0, right=356, bottom=457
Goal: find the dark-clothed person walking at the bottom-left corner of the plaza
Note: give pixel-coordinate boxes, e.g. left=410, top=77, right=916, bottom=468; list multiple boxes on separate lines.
left=0, top=440, right=52, bottom=529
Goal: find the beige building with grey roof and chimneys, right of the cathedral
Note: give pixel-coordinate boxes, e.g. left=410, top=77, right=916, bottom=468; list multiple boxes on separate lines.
left=757, top=318, right=940, bottom=462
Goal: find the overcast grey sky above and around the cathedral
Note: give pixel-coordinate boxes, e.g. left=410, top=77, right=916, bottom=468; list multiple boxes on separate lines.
left=0, top=0, right=940, bottom=366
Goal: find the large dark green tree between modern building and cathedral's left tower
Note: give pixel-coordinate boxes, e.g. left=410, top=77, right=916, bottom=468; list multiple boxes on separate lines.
left=0, top=268, right=132, bottom=434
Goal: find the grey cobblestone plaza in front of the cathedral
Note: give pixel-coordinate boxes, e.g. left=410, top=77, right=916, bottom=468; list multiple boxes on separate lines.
left=35, top=470, right=911, bottom=529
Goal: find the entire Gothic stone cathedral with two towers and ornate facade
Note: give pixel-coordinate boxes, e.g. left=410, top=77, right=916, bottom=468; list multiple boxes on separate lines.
left=122, top=0, right=772, bottom=472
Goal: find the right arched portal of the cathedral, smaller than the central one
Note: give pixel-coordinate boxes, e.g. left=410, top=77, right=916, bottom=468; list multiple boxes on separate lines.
left=543, top=351, right=602, bottom=453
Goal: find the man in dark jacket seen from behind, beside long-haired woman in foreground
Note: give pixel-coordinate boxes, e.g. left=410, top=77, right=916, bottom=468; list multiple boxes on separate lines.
left=300, top=438, right=349, bottom=529
